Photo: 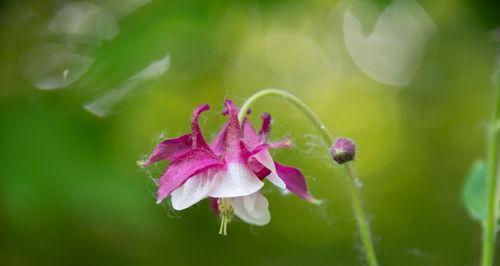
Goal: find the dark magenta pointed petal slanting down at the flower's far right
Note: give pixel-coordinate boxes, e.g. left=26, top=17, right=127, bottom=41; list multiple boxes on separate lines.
left=274, top=162, right=314, bottom=201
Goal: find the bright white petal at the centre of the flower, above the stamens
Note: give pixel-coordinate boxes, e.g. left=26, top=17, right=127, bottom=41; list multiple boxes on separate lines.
left=209, top=163, right=264, bottom=198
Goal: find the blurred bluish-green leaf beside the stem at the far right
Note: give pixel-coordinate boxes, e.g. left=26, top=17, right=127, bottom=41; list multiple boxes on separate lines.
left=462, top=160, right=488, bottom=222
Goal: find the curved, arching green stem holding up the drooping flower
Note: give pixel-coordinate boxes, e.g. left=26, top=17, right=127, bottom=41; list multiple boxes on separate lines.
left=238, top=89, right=378, bottom=266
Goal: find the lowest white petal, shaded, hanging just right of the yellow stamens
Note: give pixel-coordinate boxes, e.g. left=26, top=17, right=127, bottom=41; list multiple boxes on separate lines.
left=232, top=192, right=271, bottom=226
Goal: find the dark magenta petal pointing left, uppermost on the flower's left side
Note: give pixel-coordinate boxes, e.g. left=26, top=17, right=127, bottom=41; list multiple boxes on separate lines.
left=144, top=134, right=192, bottom=166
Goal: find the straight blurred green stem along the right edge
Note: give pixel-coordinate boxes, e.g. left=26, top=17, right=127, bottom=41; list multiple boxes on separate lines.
left=481, top=70, right=500, bottom=266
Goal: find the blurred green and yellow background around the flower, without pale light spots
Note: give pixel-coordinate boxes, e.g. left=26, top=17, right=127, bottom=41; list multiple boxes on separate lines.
left=0, top=0, right=500, bottom=265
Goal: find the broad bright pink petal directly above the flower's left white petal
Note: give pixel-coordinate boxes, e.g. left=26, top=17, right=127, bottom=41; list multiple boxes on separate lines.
left=157, top=148, right=223, bottom=203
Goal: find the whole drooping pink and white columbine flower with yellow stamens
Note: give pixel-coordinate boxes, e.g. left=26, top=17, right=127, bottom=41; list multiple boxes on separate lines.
left=144, top=100, right=314, bottom=235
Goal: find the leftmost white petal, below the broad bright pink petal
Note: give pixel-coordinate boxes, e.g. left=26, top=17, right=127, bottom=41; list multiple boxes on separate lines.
left=171, top=172, right=214, bottom=210
